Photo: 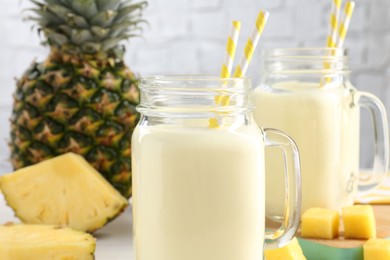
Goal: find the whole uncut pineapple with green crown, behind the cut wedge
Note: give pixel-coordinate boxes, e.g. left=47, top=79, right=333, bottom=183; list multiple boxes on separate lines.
left=10, top=0, right=146, bottom=198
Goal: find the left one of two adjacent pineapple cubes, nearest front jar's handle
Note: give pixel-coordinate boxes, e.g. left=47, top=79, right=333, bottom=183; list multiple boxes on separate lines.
left=301, top=208, right=340, bottom=239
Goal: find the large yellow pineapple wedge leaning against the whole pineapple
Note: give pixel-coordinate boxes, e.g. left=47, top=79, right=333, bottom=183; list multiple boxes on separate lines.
left=0, top=153, right=128, bottom=232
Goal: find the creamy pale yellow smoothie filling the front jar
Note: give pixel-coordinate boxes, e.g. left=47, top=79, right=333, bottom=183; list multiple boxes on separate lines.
left=132, top=125, right=265, bottom=260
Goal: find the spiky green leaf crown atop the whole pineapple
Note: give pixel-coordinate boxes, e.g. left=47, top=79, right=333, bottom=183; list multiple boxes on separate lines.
left=27, top=0, right=147, bottom=54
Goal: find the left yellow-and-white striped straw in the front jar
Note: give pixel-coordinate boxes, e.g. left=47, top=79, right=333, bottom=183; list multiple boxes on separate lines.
left=209, top=21, right=241, bottom=128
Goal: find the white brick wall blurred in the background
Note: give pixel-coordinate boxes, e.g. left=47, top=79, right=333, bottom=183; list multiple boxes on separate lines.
left=0, top=0, right=390, bottom=171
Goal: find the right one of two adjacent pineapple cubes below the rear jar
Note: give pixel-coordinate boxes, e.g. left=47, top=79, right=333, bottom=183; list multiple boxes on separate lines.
left=342, top=205, right=376, bottom=239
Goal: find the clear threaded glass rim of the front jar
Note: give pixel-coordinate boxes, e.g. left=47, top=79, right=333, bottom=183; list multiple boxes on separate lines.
left=137, top=74, right=253, bottom=117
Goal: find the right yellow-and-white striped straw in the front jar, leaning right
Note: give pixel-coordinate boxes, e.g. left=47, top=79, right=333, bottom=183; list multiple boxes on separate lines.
left=233, top=10, right=269, bottom=78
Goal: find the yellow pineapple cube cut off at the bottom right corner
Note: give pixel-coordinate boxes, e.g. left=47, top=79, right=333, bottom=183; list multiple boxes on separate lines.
left=363, top=238, right=390, bottom=260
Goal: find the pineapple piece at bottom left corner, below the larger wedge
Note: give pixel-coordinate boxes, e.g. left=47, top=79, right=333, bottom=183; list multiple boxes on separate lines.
left=0, top=222, right=96, bottom=260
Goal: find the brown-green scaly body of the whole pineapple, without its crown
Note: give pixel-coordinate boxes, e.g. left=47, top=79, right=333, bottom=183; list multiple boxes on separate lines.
left=10, top=48, right=139, bottom=198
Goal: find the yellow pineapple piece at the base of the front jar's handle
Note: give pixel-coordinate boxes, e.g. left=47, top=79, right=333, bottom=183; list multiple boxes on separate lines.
left=264, top=237, right=306, bottom=260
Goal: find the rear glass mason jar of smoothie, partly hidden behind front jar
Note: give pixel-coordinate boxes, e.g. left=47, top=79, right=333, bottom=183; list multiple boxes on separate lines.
left=253, top=48, right=389, bottom=216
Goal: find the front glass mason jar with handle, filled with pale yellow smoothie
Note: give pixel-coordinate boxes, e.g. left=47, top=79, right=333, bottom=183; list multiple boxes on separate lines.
left=132, top=75, right=300, bottom=260
